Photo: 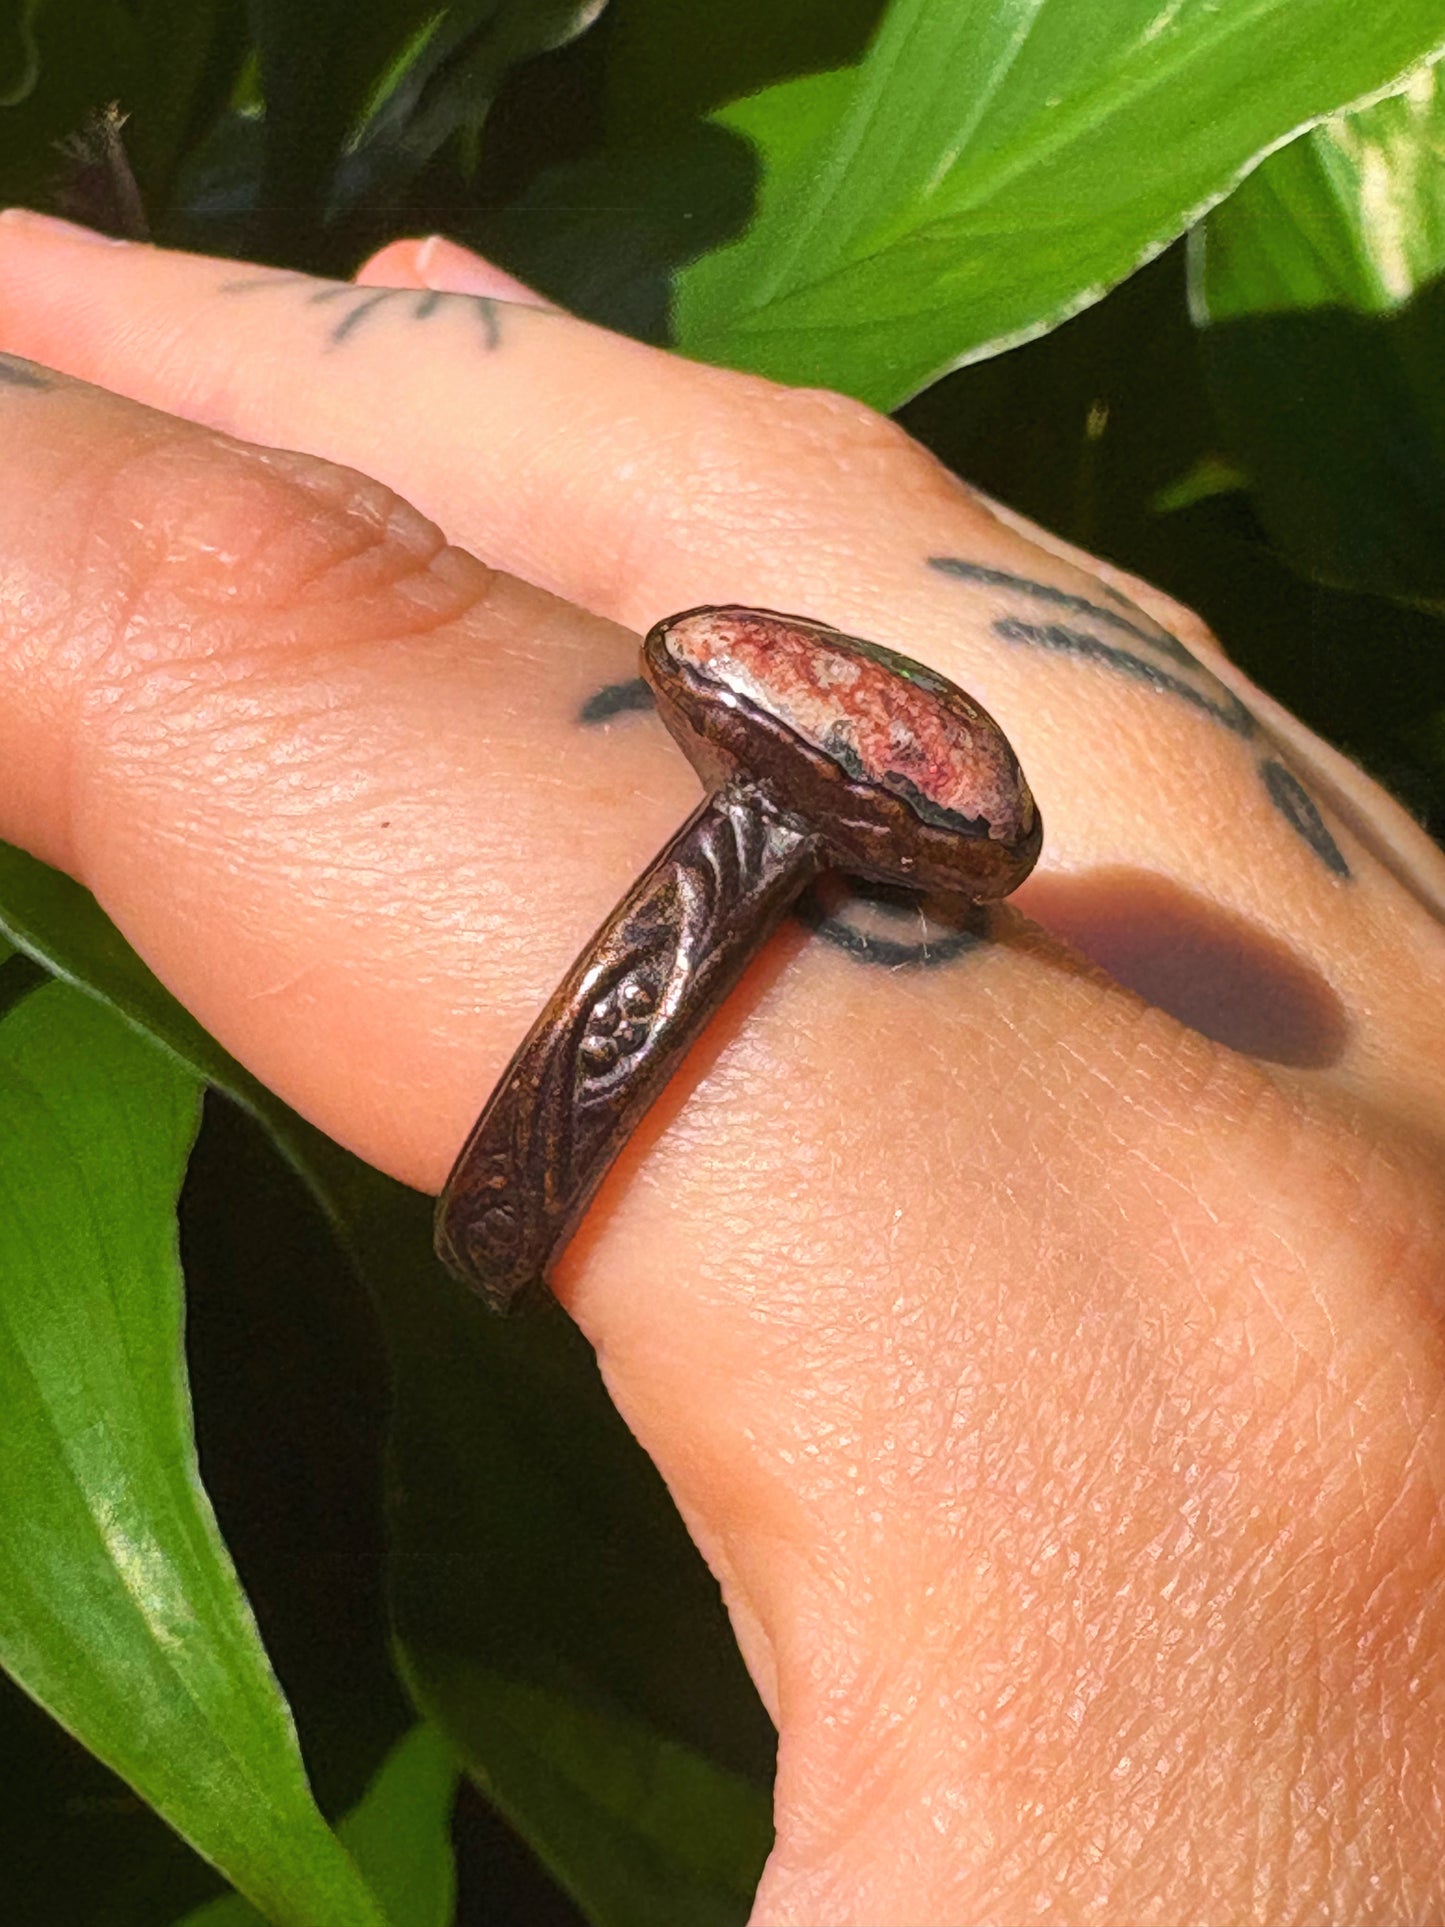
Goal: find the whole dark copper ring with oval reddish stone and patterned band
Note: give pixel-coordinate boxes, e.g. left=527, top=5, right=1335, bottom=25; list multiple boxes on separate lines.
left=435, top=607, right=1042, bottom=1312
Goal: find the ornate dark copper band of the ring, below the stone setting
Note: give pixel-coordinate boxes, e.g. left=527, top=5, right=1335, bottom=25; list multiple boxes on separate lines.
left=435, top=780, right=823, bottom=1312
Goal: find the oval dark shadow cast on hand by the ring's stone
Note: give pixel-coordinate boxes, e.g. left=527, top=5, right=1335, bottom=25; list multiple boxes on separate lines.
left=1013, top=867, right=1349, bottom=1069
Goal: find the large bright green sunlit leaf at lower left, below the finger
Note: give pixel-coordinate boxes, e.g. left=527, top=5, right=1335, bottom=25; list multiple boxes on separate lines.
left=0, top=985, right=383, bottom=1927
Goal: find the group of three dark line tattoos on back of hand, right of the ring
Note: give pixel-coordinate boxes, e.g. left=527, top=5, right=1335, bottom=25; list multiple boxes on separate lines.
left=929, top=555, right=1354, bottom=881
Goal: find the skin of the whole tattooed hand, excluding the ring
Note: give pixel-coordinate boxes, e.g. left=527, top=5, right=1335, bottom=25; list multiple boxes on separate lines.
left=0, top=218, right=1445, bottom=1927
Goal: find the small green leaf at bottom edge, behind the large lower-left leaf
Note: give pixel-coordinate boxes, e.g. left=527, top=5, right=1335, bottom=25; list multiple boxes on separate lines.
left=177, top=1725, right=457, bottom=1927
